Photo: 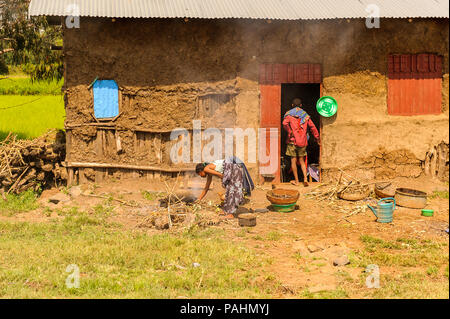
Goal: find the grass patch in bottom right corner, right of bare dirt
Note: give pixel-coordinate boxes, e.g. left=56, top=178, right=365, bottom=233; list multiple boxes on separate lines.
left=344, top=235, right=449, bottom=299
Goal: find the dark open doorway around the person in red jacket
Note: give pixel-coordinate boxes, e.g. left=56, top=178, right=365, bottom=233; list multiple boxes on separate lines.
left=280, top=83, right=321, bottom=182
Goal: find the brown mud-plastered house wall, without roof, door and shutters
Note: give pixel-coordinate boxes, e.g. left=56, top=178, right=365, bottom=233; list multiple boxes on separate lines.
left=64, top=19, right=449, bottom=182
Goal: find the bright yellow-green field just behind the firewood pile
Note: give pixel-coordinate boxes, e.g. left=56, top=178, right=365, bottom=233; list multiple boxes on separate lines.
left=0, top=95, right=65, bottom=140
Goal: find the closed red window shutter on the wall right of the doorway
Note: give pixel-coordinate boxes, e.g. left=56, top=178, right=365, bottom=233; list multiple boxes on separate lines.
left=387, top=54, right=442, bottom=115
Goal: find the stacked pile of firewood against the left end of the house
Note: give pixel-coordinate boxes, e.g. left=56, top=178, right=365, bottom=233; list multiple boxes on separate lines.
left=0, top=130, right=67, bottom=193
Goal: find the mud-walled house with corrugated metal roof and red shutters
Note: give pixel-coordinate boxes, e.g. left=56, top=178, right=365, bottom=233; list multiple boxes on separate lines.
left=29, top=0, right=449, bottom=182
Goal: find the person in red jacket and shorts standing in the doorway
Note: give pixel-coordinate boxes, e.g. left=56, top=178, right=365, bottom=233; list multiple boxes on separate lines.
left=283, top=98, right=320, bottom=186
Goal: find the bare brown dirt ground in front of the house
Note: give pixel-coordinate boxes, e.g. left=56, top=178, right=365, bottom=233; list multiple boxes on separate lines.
left=0, top=177, right=449, bottom=298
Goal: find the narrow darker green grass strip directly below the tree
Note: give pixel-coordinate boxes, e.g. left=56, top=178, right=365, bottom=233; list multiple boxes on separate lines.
left=0, top=76, right=64, bottom=95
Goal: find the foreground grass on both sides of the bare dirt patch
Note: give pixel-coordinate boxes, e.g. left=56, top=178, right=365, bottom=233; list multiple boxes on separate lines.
left=0, top=191, right=449, bottom=299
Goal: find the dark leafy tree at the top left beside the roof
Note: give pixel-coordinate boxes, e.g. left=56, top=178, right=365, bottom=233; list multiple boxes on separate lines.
left=0, top=0, right=63, bottom=80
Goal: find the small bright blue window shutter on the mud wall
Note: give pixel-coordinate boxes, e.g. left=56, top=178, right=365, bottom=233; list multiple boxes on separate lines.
left=94, top=80, right=119, bottom=119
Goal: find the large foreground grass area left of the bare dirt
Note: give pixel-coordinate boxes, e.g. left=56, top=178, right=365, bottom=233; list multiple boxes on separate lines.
left=0, top=221, right=277, bottom=298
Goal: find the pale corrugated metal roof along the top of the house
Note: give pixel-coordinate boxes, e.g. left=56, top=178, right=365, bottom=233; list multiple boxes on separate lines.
left=29, top=0, right=449, bottom=20
